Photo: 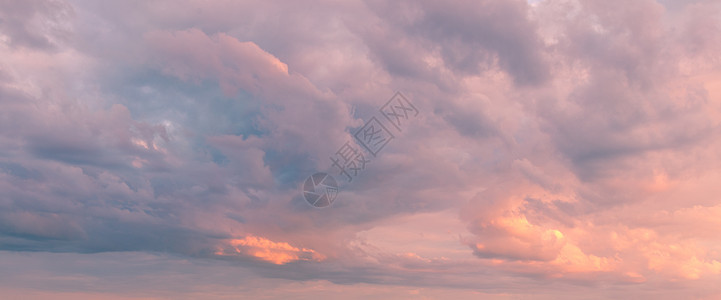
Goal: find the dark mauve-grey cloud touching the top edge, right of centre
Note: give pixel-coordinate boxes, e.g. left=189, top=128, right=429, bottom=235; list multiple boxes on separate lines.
left=368, top=1, right=549, bottom=86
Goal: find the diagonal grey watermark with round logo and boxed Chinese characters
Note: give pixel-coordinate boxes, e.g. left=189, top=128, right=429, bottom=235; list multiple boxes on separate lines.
left=303, top=92, right=419, bottom=207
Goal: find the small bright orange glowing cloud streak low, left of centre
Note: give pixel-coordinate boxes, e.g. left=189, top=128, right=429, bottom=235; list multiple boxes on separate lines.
left=215, top=235, right=326, bottom=265
